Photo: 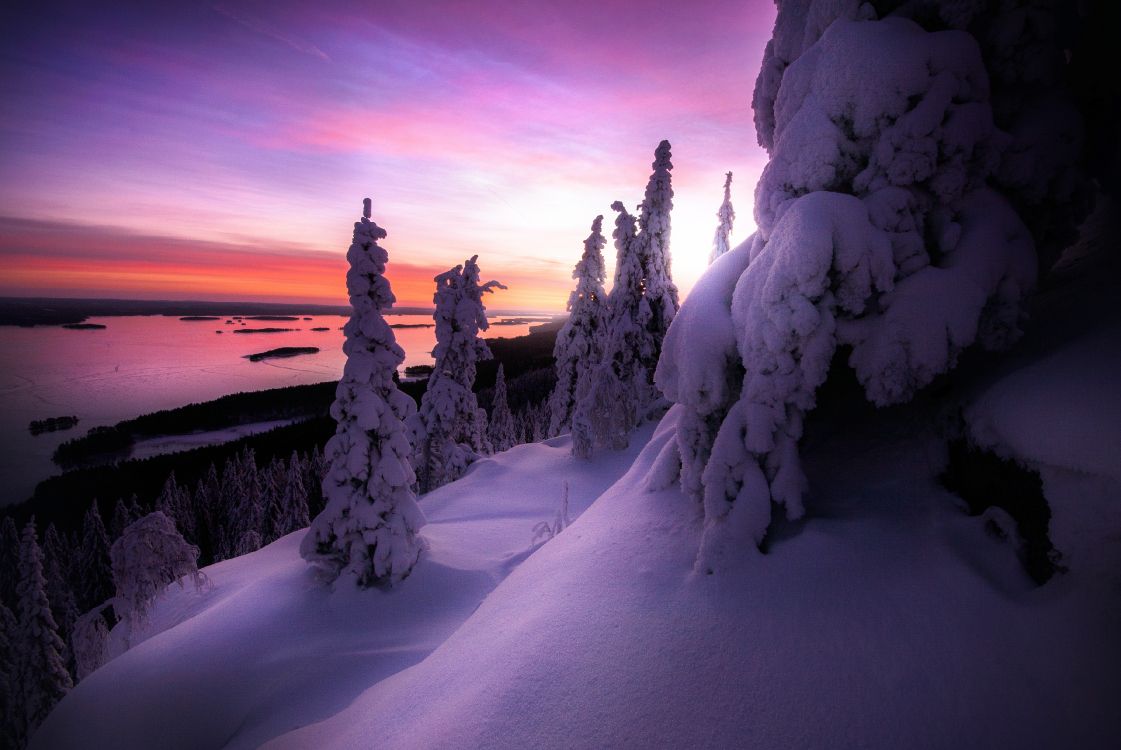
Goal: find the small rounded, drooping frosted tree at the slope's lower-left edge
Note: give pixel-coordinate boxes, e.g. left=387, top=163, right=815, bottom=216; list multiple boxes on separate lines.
left=109, top=510, right=205, bottom=629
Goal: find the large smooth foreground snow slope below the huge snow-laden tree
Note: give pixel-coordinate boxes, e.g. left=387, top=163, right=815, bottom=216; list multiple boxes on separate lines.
left=269, top=394, right=1121, bottom=749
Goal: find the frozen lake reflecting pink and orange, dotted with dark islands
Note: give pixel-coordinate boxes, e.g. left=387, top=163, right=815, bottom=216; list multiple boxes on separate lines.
left=0, top=315, right=542, bottom=504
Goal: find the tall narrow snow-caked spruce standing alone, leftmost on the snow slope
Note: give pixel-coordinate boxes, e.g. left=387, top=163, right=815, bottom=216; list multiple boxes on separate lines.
left=299, top=198, right=424, bottom=587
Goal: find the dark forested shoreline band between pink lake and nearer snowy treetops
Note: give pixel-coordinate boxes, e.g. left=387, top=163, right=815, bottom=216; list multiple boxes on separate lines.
left=0, top=323, right=561, bottom=531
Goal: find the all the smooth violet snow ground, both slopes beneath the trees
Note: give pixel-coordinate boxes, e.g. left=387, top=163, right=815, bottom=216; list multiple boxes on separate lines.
left=33, top=318, right=1121, bottom=749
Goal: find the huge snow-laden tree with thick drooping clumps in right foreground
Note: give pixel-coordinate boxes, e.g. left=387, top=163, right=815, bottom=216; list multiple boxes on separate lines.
left=657, top=1, right=1073, bottom=570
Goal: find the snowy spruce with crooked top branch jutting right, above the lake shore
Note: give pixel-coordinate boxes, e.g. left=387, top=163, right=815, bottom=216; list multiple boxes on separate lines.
left=409, top=256, right=506, bottom=492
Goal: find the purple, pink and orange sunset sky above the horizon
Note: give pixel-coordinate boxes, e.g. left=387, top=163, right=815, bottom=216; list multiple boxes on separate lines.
left=0, top=0, right=775, bottom=311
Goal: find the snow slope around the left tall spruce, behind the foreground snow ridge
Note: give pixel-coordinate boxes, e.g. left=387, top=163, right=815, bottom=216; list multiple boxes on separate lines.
left=33, top=426, right=652, bottom=750
